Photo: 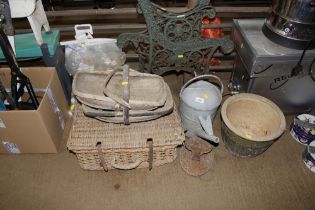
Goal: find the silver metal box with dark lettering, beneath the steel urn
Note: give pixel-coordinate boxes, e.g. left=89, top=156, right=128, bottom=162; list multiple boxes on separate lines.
left=230, top=19, right=315, bottom=114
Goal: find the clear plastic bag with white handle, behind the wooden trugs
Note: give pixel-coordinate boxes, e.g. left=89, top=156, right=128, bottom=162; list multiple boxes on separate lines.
left=61, top=24, right=126, bottom=75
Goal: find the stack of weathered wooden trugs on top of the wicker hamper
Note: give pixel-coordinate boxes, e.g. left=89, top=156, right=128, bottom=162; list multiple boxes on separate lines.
left=73, top=65, right=174, bottom=124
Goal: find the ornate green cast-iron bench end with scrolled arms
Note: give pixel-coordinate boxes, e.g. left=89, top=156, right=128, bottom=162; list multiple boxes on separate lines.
left=117, top=0, right=233, bottom=75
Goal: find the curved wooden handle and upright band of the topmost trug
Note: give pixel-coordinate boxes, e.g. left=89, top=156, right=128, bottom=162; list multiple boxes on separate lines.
left=103, top=65, right=131, bottom=125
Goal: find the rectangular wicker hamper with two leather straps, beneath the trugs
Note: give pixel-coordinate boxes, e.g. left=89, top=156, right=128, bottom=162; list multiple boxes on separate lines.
left=67, top=105, right=185, bottom=171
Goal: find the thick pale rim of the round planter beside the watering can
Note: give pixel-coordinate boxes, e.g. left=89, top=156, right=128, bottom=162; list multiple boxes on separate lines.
left=221, top=93, right=286, bottom=142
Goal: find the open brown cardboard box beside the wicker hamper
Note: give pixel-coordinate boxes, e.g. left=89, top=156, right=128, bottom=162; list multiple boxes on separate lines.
left=0, top=67, right=69, bottom=154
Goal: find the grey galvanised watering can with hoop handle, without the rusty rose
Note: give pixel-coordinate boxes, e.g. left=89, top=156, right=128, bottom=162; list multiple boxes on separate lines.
left=179, top=75, right=223, bottom=143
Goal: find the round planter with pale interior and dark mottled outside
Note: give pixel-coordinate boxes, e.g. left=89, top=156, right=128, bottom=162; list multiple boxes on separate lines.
left=221, top=93, right=285, bottom=158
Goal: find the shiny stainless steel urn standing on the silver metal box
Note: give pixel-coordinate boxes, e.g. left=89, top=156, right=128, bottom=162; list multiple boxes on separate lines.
left=264, top=0, right=315, bottom=49
